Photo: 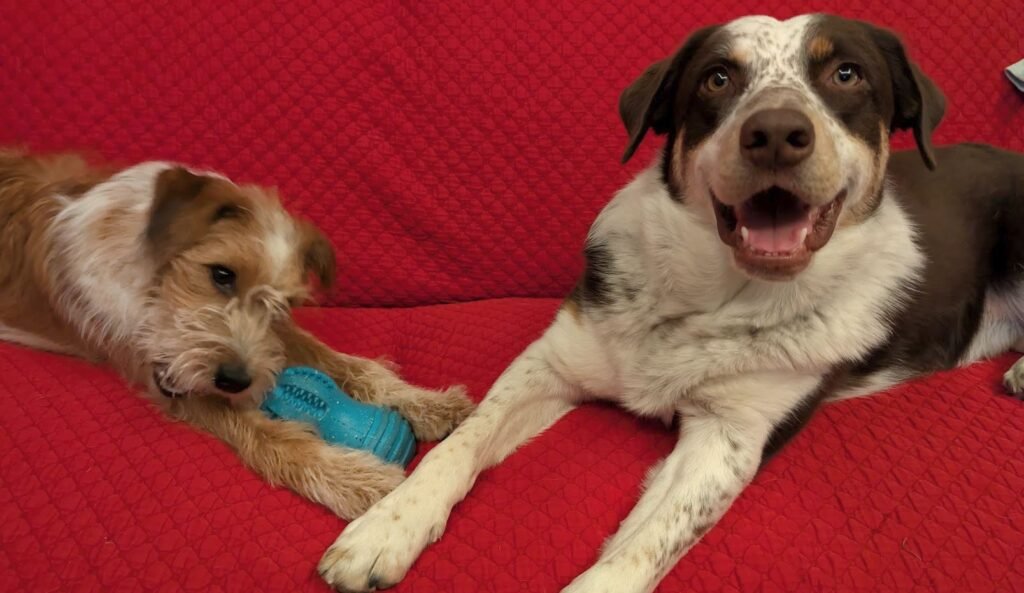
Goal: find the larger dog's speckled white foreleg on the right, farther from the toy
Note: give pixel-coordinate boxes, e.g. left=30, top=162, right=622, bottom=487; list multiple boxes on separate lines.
left=562, top=378, right=816, bottom=593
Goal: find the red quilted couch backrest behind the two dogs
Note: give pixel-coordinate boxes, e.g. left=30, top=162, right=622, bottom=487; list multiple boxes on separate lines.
left=0, top=0, right=1024, bottom=305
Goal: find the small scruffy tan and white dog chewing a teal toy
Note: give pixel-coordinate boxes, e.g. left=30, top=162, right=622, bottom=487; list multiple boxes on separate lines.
left=0, top=151, right=472, bottom=518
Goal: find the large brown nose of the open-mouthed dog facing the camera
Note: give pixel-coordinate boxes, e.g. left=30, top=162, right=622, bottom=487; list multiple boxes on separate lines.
left=739, top=109, right=814, bottom=169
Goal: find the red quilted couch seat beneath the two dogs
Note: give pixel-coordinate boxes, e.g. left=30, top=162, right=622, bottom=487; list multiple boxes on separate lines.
left=0, top=299, right=1024, bottom=593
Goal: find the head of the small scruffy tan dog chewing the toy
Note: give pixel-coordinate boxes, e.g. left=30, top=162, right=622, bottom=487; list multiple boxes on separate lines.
left=144, top=168, right=335, bottom=400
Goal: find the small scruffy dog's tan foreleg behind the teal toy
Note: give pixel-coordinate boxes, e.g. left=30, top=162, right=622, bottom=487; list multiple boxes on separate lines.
left=279, top=322, right=473, bottom=440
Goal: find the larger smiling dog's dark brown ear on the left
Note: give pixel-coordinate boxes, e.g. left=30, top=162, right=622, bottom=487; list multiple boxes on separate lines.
left=618, top=26, right=718, bottom=163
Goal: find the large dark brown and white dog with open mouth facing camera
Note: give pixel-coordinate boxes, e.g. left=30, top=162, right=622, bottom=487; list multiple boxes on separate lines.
left=319, top=15, right=1024, bottom=593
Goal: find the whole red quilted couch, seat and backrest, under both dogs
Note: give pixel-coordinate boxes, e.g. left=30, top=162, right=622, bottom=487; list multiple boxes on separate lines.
left=0, top=0, right=1024, bottom=593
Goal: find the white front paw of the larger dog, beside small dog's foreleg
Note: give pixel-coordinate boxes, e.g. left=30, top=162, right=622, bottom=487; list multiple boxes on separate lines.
left=317, top=493, right=443, bottom=593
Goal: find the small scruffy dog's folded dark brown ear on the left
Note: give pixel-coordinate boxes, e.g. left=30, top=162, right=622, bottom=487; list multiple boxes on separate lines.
left=145, top=167, right=242, bottom=264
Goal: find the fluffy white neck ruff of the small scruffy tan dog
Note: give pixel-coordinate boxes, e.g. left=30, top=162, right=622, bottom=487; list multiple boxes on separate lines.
left=49, top=163, right=170, bottom=374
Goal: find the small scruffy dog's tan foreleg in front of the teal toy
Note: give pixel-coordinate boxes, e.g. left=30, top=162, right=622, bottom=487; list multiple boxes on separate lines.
left=168, top=397, right=406, bottom=519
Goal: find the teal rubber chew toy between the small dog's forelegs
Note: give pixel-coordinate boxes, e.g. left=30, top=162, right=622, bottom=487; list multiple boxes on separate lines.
left=262, top=367, right=416, bottom=467
